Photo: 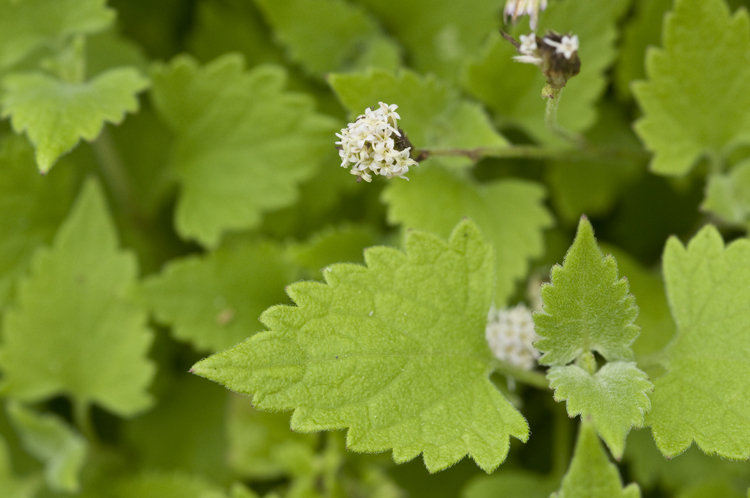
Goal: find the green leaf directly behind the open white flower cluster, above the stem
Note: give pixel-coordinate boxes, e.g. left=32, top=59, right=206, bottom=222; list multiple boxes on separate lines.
left=328, top=69, right=508, bottom=169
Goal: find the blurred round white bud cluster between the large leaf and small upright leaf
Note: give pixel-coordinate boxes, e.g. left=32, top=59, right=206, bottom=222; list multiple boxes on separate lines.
left=485, top=304, right=540, bottom=370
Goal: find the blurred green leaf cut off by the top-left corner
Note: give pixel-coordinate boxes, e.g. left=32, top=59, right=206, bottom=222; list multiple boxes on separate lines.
left=0, top=0, right=115, bottom=70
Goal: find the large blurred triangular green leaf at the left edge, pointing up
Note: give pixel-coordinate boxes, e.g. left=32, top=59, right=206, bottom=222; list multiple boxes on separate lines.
left=0, top=181, right=154, bottom=416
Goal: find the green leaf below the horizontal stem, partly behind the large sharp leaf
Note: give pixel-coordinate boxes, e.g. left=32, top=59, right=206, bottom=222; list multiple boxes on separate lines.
left=383, top=166, right=552, bottom=306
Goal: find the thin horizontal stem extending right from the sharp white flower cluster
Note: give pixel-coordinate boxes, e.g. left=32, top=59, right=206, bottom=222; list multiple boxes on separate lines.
left=418, top=145, right=651, bottom=163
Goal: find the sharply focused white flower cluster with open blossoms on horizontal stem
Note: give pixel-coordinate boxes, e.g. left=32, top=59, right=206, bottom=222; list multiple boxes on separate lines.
left=336, top=102, right=418, bottom=182
